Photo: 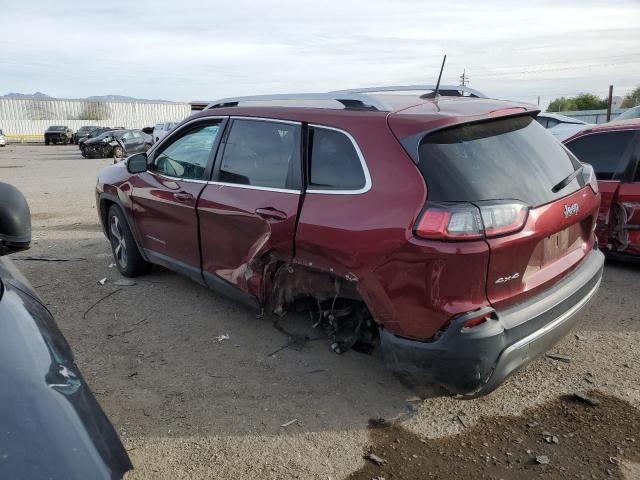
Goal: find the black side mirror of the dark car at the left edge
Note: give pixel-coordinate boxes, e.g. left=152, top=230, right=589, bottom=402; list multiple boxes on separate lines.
left=0, top=182, right=31, bottom=256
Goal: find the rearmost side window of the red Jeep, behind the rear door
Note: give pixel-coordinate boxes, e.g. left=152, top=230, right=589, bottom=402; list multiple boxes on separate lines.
left=309, top=127, right=366, bottom=190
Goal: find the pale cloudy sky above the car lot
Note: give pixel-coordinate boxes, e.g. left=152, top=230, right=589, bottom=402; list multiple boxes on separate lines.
left=0, top=0, right=640, bottom=106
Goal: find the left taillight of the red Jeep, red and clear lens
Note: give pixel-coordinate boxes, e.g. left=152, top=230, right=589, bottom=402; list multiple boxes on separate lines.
left=415, top=202, right=529, bottom=240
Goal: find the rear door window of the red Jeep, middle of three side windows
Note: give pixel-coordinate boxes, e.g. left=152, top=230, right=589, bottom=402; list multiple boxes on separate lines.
left=216, top=120, right=301, bottom=190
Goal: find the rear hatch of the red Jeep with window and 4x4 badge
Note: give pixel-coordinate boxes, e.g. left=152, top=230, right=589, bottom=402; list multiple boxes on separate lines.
left=418, top=114, right=600, bottom=308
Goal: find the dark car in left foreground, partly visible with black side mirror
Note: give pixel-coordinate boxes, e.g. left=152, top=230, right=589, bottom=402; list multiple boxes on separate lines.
left=0, top=183, right=132, bottom=480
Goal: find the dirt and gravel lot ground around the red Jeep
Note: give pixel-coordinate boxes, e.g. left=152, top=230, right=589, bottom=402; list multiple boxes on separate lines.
left=0, top=145, right=640, bottom=480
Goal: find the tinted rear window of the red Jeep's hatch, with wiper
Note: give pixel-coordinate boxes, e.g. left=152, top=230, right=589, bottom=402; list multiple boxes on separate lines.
left=418, top=116, right=581, bottom=207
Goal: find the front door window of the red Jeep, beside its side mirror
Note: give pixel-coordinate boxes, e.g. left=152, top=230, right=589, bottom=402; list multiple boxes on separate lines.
left=149, top=124, right=220, bottom=180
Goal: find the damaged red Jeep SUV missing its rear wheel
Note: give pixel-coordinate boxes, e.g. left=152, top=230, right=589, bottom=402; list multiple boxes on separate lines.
left=97, top=86, right=604, bottom=395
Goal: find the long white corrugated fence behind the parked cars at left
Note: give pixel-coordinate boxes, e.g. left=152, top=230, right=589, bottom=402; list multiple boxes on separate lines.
left=0, top=98, right=191, bottom=141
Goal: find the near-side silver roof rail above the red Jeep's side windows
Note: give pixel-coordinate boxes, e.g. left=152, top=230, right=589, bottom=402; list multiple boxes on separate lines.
left=205, top=92, right=393, bottom=112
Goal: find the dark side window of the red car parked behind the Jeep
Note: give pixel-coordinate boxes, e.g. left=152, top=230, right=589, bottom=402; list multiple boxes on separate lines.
left=567, top=131, right=635, bottom=180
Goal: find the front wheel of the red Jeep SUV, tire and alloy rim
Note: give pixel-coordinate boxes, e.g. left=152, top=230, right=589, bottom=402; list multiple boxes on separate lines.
left=107, top=205, right=150, bottom=277
